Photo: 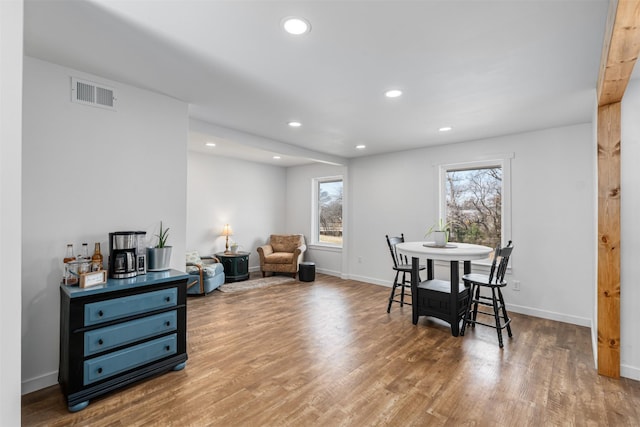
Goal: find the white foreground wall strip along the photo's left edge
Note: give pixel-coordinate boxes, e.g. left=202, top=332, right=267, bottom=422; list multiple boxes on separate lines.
left=0, top=0, right=23, bottom=426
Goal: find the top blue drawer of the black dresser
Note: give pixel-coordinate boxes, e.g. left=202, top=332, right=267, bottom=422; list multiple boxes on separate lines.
left=84, top=288, right=178, bottom=326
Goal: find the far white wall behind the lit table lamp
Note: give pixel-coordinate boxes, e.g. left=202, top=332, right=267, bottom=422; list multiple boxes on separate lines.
left=187, top=152, right=287, bottom=271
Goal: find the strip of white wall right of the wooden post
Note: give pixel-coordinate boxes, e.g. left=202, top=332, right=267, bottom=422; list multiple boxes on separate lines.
left=620, top=80, right=640, bottom=380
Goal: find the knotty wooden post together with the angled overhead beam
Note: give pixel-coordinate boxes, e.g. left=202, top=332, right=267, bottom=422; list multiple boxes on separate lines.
left=597, top=0, right=640, bottom=378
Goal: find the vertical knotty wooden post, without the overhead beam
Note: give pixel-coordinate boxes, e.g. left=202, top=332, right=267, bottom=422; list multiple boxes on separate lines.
left=598, top=102, right=621, bottom=378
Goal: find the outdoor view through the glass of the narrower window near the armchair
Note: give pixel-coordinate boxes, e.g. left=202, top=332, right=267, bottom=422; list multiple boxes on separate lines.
left=318, top=180, right=342, bottom=246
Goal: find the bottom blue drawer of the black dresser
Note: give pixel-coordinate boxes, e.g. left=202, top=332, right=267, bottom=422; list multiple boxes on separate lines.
left=84, top=334, right=178, bottom=385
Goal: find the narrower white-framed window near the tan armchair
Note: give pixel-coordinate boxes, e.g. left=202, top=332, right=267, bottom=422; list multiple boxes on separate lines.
left=312, top=177, right=343, bottom=247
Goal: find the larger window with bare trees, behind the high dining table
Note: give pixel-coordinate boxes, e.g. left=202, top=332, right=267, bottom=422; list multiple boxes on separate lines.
left=439, top=156, right=511, bottom=248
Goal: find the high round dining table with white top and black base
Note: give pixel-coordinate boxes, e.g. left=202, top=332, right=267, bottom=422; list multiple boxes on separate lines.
left=396, top=242, right=493, bottom=337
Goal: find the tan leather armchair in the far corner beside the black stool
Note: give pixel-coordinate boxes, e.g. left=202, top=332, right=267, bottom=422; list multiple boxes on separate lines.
left=258, top=234, right=307, bottom=278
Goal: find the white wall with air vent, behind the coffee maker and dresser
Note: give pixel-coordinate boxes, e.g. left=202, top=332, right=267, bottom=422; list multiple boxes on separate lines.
left=22, top=57, right=188, bottom=393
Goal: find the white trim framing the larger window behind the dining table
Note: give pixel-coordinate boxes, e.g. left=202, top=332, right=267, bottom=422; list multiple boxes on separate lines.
left=435, top=153, right=514, bottom=265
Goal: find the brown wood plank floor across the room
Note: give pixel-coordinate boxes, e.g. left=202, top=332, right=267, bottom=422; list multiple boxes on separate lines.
left=22, top=274, right=640, bottom=426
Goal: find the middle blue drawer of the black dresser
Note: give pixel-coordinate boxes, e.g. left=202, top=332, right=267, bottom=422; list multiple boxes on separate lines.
left=84, top=310, right=178, bottom=356
